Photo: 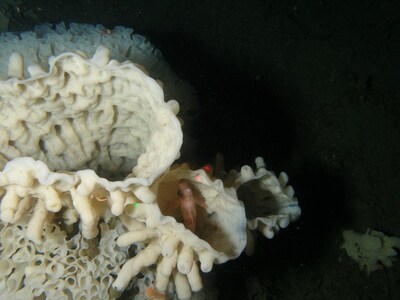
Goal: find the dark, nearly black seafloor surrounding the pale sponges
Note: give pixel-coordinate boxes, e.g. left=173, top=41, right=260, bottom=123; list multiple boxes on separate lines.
left=0, top=0, right=400, bottom=300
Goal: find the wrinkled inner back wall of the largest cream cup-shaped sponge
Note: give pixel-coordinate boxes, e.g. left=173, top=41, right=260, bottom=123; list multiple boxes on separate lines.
left=0, top=46, right=182, bottom=185
